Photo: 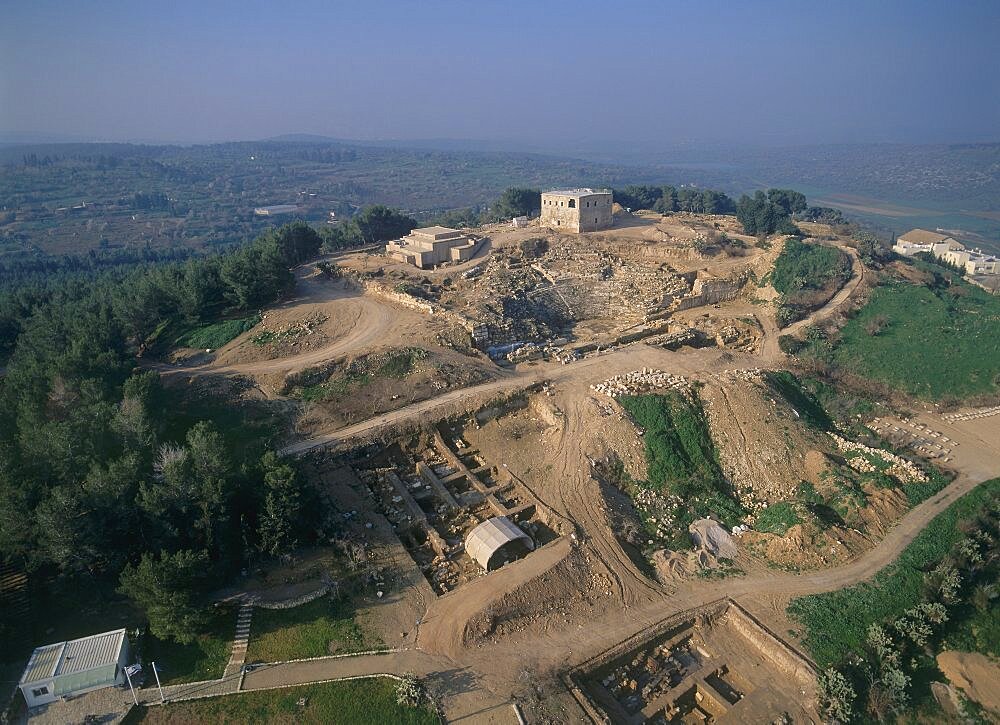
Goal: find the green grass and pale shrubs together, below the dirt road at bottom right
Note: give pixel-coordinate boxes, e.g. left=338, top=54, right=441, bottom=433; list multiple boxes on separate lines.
left=788, top=479, right=1000, bottom=722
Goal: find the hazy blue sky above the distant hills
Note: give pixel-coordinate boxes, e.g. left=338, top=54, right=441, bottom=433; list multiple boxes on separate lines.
left=0, top=0, right=1000, bottom=148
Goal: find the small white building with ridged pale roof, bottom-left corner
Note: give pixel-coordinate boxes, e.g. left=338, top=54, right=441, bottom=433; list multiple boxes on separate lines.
left=18, top=629, right=129, bottom=708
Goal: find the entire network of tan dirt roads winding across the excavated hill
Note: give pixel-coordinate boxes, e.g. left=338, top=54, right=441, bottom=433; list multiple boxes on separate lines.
left=139, top=243, right=1000, bottom=717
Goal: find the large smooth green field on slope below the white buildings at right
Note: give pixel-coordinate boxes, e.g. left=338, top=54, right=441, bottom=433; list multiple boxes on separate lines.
left=806, top=280, right=1000, bottom=400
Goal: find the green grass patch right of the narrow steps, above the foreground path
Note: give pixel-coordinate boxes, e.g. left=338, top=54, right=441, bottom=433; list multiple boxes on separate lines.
left=247, top=597, right=382, bottom=662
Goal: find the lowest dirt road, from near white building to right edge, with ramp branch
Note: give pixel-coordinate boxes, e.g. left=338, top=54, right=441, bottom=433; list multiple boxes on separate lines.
left=129, top=466, right=996, bottom=723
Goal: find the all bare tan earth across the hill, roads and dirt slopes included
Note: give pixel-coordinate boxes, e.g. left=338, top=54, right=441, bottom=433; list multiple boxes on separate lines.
left=150, top=218, right=1000, bottom=722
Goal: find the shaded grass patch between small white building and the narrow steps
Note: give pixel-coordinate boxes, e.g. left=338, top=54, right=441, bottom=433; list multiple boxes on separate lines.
left=142, top=608, right=236, bottom=685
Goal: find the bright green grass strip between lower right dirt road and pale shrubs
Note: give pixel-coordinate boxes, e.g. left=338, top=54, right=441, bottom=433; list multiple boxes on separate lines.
left=788, top=479, right=1000, bottom=667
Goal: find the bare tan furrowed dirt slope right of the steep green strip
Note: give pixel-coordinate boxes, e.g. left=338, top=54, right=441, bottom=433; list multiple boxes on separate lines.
left=701, top=375, right=830, bottom=513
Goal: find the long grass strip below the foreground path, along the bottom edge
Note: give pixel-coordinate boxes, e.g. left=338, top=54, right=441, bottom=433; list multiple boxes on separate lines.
left=123, top=677, right=440, bottom=725
